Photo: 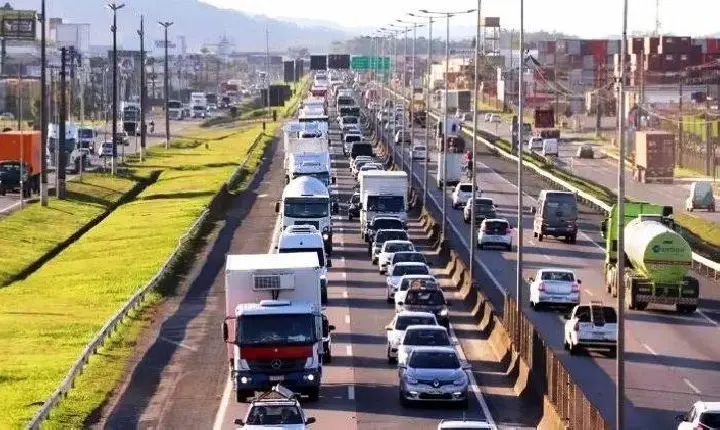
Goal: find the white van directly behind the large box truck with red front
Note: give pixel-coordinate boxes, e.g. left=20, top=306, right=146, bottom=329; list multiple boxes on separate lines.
left=277, top=225, right=332, bottom=305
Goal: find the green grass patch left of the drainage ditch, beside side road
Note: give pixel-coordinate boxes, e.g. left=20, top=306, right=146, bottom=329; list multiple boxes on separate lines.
left=0, top=173, right=137, bottom=285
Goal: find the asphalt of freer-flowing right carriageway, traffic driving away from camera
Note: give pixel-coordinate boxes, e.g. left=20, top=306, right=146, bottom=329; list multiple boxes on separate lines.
left=386, top=113, right=720, bottom=429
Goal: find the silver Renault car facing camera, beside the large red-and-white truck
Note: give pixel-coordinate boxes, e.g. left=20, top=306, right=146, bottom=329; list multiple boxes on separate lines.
left=398, top=346, right=470, bottom=407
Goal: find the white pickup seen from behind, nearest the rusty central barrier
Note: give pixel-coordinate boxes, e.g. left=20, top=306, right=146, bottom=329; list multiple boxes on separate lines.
left=563, top=301, right=617, bottom=355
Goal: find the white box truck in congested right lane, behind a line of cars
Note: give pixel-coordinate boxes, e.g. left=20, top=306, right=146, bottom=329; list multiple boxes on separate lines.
left=358, top=170, right=408, bottom=237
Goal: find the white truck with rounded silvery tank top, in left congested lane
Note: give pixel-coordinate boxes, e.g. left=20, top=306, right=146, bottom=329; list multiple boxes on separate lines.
left=275, top=176, right=340, bottom=254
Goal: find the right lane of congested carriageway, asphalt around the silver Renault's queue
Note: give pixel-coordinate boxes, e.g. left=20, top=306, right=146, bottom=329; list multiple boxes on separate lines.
left=338, top=149, right=492, bottom=429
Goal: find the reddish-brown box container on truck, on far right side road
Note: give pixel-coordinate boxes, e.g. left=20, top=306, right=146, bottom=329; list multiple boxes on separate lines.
left=635, top=131, right=675, bottom=182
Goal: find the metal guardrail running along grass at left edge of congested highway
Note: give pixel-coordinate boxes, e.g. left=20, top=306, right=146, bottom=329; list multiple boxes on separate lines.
left=26, top=132, right=264, bottom=430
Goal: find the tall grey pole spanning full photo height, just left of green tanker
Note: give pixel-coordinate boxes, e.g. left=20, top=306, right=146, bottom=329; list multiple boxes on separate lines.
left=609, top=0, right=628, bottom=430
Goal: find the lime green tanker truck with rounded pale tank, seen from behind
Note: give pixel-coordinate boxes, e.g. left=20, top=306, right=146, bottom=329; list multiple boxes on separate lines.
left=604, top=202, right=700, bottom=313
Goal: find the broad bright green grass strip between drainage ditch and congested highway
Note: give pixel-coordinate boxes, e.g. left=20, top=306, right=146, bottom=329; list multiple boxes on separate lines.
left=0, top=126, right=260, bottom=428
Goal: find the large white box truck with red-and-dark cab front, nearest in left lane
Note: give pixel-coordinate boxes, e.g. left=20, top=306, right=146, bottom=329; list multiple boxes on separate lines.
left=222, top=252, right=323, bottom=402
